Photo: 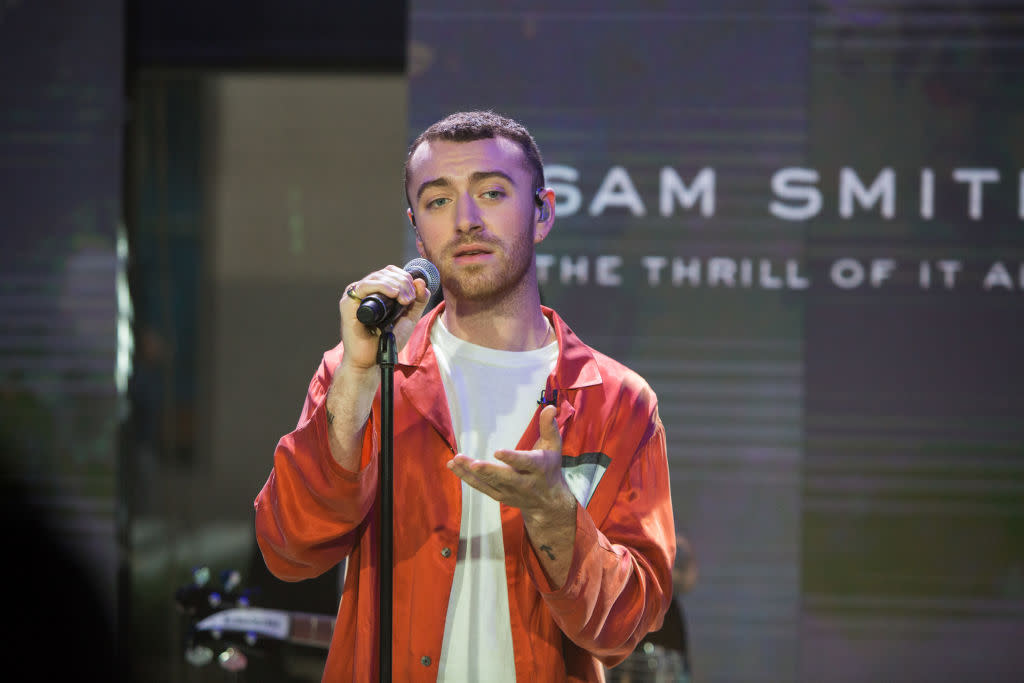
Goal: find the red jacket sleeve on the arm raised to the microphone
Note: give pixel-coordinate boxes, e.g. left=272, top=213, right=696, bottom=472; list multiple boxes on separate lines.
left=255, top=346, right=377, bottom=581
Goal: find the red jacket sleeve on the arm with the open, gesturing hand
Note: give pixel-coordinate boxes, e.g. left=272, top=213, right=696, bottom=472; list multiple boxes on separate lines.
left=522, top=409, right=676, bottom=667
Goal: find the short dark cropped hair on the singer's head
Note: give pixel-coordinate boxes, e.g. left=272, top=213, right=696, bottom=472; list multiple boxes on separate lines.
left=406, top=111, right=544, bottom=206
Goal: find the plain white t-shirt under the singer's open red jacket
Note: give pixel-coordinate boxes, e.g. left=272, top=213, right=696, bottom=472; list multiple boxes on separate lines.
left=430, top=317, right=558, bottom=683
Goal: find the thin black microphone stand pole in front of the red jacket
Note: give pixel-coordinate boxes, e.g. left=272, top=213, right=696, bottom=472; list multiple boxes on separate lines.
left=377, top=325, right=397, bottom=683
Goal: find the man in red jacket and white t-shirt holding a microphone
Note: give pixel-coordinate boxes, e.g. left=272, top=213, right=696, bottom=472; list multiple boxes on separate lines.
left=256, top=112, right=675, bottom=682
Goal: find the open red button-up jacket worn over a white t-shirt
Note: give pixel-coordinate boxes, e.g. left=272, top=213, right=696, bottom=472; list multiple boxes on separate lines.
left=255, top=304, right=676, bottom=683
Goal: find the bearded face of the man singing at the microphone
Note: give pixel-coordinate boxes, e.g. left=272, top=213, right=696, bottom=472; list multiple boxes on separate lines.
left=406, top=137, right=548, bottom=302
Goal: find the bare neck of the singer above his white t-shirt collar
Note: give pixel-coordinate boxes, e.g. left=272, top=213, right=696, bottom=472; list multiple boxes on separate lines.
left=441, top=290, right=554, bottom=351
